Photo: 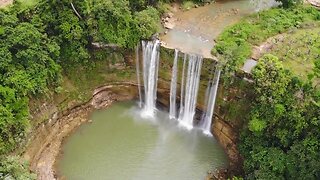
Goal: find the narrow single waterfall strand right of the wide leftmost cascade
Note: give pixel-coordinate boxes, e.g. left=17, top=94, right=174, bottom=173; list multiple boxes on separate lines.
left=169, top=49, right=179, bottom=119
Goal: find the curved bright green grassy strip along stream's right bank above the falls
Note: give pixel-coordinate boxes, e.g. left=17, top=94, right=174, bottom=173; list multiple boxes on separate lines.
left=212, top=6, right=320, bottom=77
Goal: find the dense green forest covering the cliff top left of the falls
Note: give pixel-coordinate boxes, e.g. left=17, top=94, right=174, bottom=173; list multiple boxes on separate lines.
left=0, top=0, right=159, bottom=179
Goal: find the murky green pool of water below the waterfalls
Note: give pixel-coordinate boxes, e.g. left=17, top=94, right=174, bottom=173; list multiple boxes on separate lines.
left=57, top=101, right=227, bottom=180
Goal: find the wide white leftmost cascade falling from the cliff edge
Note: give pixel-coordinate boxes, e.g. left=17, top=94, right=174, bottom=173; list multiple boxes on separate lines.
left=142, top=40, right=160, bottom=117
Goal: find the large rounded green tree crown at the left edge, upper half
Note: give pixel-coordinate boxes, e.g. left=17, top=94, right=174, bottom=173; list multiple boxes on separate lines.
left=0, top=23, right=60, bottom=95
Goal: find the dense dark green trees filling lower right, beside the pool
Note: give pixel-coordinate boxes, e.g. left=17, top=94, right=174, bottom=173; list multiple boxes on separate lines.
left=240, top=55, right=320, bottom=179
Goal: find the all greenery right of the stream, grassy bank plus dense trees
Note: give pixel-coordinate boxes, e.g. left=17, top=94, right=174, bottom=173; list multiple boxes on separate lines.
left=213, top=3, right=320, bottom=179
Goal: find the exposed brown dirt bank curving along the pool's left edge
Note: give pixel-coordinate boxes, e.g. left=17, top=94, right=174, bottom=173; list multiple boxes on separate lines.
left=23, top=83, right=137, bottom=180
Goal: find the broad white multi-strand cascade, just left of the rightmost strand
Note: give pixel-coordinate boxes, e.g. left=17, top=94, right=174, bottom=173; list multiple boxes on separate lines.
left=178, top=55, right=202, bottom=129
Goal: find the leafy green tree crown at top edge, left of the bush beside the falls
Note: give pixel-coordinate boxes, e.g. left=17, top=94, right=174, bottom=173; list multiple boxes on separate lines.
left=87, top=0, right=139, bottom=48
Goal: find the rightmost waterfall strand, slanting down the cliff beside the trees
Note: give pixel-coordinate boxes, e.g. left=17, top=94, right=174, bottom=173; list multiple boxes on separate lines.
left=200, top=67, right=221, bottom=135
